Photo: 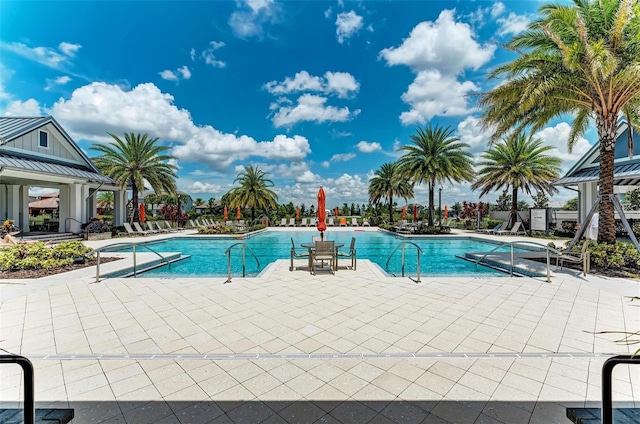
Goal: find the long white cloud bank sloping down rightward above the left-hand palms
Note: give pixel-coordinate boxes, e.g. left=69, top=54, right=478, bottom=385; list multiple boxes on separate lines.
left=50, top=82, right=311, bottom=170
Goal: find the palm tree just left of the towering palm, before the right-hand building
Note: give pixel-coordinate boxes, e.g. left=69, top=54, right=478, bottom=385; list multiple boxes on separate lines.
left=471, top=134, right=562, bottom=224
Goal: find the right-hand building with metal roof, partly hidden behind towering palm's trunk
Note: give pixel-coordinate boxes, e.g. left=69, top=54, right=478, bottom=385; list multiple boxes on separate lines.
left=554, top=119, right=640, bottom=217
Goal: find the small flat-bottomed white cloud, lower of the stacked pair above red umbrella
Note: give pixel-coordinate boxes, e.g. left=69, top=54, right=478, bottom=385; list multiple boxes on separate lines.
left=273, top=94, right=360, bottom=127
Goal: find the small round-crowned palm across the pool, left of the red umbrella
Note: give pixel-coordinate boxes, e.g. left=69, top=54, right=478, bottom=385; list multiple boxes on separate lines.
left=229, top=166, right=278, bottom=221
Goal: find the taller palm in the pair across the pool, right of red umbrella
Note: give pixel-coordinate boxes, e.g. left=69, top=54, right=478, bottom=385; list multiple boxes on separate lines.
left=398, top=125, right=474, bottom=226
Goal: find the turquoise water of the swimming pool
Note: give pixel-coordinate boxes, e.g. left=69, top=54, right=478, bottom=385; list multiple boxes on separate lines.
left=105, top=231, right=507, bottom=278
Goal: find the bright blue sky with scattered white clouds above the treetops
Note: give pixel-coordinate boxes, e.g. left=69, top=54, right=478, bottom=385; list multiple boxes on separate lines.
left=0, top=0, right=596, bottom=205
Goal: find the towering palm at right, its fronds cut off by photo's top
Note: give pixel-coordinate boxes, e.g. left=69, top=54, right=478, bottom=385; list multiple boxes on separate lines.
left=480, top=0, right=640, bottom=244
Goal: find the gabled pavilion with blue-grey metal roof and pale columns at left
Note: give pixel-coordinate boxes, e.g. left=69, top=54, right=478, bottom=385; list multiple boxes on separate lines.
left=0, top=116, right=127, bottom=232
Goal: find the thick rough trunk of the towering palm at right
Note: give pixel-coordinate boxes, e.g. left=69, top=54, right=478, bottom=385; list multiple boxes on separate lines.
left=597, top=116, right=616, bottom=244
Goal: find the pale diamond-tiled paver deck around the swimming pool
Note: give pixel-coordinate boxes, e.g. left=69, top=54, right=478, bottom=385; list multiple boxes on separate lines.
left=0, top=227, right=640, bottom=424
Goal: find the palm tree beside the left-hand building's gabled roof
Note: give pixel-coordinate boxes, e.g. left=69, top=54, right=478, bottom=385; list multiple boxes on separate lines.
left=91, top=133, right=178, bottom=222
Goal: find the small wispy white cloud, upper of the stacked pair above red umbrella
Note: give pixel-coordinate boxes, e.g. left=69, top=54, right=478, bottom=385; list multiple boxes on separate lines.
left=264, top=71, right=360, bottom=97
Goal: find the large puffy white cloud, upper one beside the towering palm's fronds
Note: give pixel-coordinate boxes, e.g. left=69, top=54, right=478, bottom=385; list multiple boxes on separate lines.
left=380, top=10, right=496, bottom=75
